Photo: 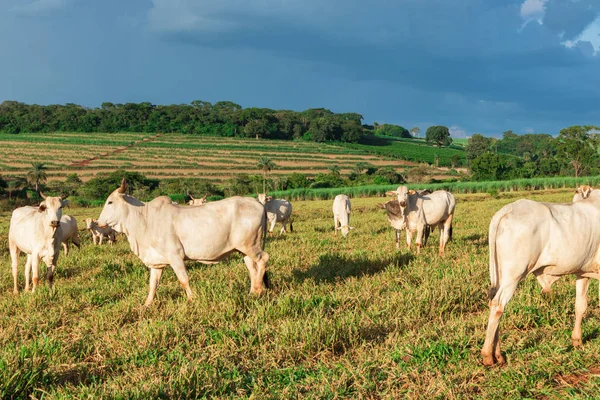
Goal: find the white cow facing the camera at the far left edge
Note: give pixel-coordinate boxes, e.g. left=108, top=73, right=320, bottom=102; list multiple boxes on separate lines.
left=8, top=192, right=67, bottom=293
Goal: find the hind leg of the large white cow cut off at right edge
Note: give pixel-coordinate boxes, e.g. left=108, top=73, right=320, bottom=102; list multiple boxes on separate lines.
left=481, top=280, right=519, bottom=366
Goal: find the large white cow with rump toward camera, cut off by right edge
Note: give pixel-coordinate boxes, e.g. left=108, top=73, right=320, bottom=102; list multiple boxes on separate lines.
left=481, top=191, right=600, bottom=365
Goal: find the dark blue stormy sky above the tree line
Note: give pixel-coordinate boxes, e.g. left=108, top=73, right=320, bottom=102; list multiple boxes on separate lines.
left=0, top=0, right=600, bottom=137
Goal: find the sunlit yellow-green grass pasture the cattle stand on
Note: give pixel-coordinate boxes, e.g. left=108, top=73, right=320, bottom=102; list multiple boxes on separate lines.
left=0, top=190, right=600, bottom=399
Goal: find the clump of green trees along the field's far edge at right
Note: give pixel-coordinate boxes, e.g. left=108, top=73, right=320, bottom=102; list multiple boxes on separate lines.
left=466, top=125, right=600, bottom=181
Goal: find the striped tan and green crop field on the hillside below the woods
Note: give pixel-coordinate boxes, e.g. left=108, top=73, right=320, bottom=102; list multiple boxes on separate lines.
left=0, top=133, right=432, bottom=183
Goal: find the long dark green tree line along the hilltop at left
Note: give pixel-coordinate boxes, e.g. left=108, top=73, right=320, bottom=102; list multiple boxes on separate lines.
left=0, top=100, right=372, bottom=142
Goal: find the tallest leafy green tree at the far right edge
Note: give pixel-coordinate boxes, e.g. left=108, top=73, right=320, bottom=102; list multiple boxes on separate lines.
left=557, top=126, right=600, bottom=177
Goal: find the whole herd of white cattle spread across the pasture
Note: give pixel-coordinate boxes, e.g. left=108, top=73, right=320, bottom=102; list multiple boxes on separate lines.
left=8, top=180, right=600, bottom=365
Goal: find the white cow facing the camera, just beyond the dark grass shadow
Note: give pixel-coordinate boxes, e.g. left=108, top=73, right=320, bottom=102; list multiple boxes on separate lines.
left=386, top=186, right=456, bottom=255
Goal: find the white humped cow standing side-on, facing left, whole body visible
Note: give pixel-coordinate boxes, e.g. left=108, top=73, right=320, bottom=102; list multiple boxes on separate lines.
left=98, top=179, right=269, bottom=306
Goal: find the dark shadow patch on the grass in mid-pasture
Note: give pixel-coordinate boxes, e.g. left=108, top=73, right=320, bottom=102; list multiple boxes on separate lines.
left=294, top=253, right=415, bottom=283
